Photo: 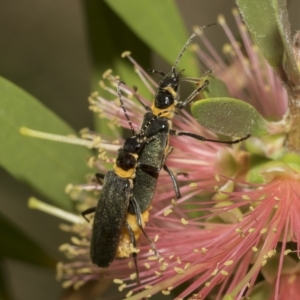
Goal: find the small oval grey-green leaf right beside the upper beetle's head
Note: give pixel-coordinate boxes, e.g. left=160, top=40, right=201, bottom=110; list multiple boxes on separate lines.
left=191, top=98, right=268, bottom=137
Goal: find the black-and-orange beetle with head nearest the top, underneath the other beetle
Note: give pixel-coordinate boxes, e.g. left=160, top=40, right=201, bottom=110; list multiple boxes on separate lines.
left=129, top=26, right=250, bottom=214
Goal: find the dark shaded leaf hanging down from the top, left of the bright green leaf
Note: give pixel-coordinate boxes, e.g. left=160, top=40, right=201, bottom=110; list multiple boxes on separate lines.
left=82, top=0, right=151, bottom=135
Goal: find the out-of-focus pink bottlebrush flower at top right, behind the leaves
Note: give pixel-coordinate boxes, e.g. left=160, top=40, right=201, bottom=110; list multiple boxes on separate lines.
left=197, top=9, right=288, bottom=119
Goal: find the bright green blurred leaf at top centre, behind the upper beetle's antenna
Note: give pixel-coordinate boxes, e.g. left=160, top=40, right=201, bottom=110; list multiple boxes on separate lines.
left=105, top=0, right=199, bottom=77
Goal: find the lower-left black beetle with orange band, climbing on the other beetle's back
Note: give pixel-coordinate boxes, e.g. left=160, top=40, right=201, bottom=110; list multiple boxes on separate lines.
left=82, top=81, right=158, bottom=285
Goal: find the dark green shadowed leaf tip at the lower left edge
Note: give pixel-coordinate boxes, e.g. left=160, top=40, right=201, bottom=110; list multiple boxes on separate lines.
left=0, top=214, right=56, bottom=268
